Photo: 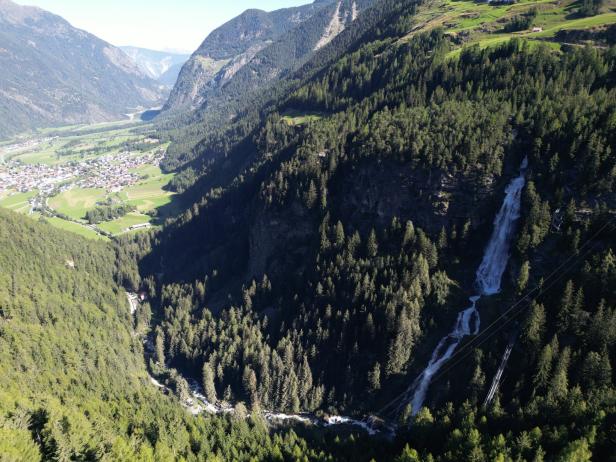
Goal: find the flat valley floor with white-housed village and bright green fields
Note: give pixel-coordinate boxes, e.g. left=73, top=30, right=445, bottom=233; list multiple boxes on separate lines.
left=0, top=124, right=174, bottom=238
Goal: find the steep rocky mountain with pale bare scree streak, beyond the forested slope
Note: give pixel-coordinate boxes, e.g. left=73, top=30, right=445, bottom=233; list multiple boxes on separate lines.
left=165, top=0, right=372, bottom=109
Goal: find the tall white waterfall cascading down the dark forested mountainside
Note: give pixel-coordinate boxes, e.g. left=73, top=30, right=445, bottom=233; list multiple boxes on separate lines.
left=411, top=158, right=528, bottom=415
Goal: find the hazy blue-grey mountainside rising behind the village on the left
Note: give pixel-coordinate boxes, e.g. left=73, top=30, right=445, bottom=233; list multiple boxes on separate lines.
left=0, top=0, right=162, bottom=136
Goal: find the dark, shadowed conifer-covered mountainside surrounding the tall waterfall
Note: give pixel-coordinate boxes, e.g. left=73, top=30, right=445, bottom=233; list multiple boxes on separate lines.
left=142, top=2, right=616, bottom=460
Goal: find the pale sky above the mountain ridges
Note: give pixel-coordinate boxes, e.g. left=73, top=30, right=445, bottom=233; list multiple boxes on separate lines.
left=17, top=0, right=312, bottom=53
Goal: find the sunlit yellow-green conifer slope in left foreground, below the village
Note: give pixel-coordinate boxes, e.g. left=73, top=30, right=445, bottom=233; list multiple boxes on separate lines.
left=0, top=210, right=358, bottom=462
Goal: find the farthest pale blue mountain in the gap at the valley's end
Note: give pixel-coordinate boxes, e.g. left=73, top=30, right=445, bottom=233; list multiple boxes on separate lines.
left=120, top=46, right=190, bottom=87
